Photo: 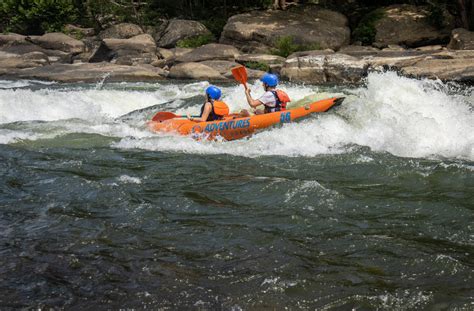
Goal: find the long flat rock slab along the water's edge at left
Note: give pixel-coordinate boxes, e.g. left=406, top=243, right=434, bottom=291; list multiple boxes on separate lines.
left=4, top=63, right=167, bottom=83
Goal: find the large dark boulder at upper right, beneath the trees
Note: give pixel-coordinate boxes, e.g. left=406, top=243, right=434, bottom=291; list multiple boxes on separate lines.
left=373, top=4, right=452, bottom=48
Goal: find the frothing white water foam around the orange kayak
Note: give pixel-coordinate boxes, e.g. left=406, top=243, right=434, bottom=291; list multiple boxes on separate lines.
left=0, top=72, right=474, bottom=160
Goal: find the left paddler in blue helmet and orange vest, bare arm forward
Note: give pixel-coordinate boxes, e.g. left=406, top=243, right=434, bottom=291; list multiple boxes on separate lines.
left=187, top=85, right=229, bottom=122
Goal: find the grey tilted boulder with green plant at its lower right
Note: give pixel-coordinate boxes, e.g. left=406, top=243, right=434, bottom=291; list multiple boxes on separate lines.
left=154, top=19, right=212, bottom=48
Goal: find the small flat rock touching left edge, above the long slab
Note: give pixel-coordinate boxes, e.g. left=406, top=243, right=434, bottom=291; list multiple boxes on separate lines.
left=0, top=51, right=49, bottom=70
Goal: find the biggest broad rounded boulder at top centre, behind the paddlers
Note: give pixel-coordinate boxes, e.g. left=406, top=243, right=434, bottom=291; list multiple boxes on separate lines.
left=220, top=6, right=350, bottom=52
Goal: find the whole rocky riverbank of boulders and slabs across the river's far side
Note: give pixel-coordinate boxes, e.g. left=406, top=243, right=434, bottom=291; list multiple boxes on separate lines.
left=0, top=5, right=474, bottom=84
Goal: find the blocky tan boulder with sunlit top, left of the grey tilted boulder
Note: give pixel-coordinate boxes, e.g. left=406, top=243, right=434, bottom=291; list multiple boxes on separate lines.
left=89, top=34, right=158, bottom=65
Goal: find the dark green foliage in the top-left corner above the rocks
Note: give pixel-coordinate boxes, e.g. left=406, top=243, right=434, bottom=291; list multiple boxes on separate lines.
left=0, top=0, right=77, bottom=34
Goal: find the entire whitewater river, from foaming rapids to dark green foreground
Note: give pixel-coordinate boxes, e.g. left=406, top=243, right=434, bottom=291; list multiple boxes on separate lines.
left=0, top=72, right=474, bottom=310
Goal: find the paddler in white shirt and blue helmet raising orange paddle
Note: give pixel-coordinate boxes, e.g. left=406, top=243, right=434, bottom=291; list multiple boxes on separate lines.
left=242, top=73, right=288, bottom=114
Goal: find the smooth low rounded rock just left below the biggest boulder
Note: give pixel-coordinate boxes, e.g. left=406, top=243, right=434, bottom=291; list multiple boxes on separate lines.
left=176, top=43, right=240, bottom=63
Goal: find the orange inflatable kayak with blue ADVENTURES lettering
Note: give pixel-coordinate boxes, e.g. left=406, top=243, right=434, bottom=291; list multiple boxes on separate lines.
left=148, top=97, right=344, bottom=140
